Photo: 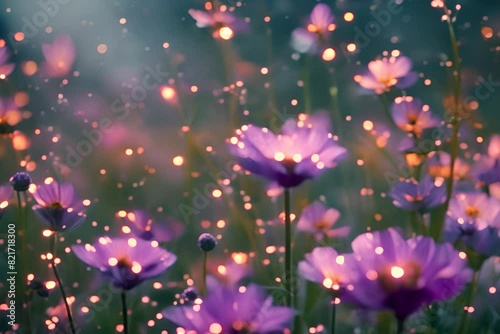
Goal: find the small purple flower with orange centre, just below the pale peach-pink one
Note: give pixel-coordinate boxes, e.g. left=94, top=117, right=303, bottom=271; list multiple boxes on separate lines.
left=391, top=96, right=440, bottom=137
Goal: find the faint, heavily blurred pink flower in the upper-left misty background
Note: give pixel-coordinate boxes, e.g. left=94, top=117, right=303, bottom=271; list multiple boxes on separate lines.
left=42, top=35, right=76, bottom=78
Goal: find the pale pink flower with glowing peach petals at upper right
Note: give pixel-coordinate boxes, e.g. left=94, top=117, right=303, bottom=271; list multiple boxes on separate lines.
left=354, top=56, right=418, bottom=94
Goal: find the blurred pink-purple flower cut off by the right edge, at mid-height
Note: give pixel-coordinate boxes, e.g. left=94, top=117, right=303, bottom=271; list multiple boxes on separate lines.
left=472, top=135, right=500, bottom=185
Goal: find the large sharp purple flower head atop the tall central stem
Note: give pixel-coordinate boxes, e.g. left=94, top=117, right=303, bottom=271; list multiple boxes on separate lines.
left=229, top=114, right=347, bottom=188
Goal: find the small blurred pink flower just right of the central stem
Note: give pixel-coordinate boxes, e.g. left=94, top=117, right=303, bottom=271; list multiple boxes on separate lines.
left=297, top=202, right=351, bottom=241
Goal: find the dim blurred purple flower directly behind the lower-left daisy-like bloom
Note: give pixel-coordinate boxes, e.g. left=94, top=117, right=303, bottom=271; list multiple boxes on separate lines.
left=125, top=210, right=184, bottom=242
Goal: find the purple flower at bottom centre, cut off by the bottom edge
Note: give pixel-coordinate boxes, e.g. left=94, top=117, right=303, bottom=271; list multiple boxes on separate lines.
left=162, top=285, right=294, bottom=334
